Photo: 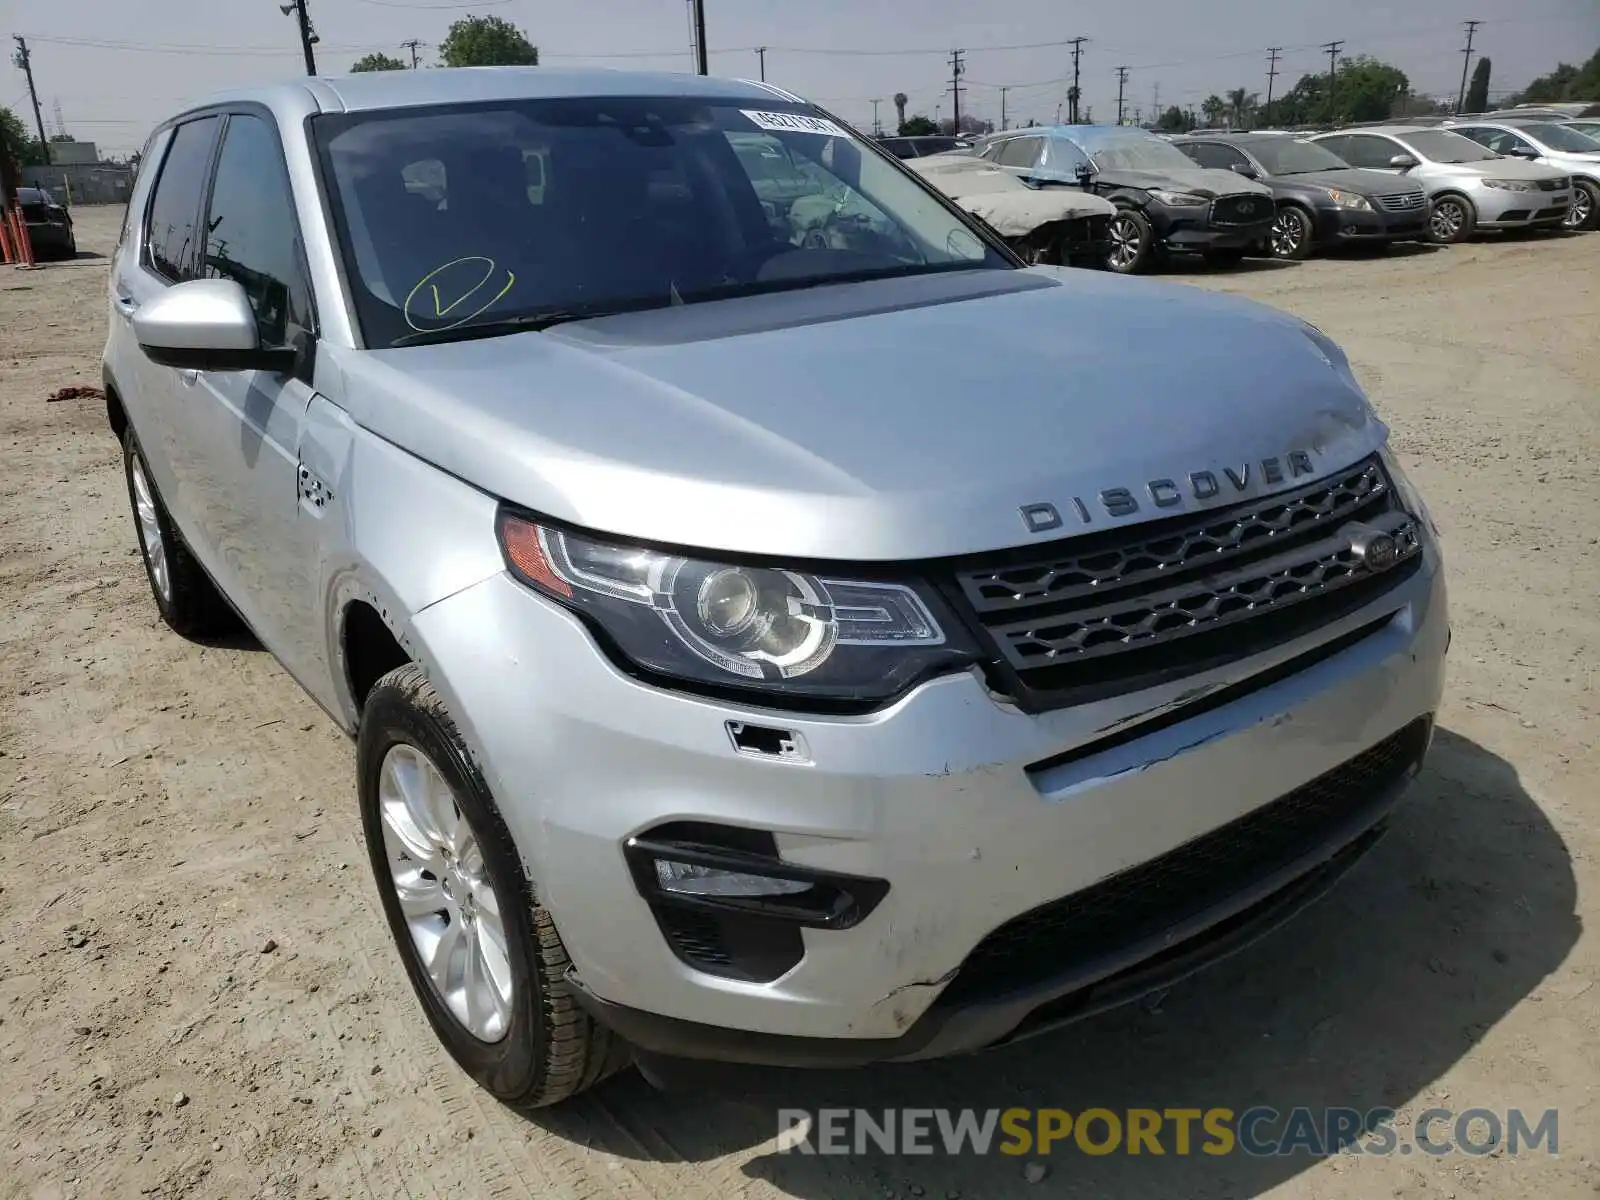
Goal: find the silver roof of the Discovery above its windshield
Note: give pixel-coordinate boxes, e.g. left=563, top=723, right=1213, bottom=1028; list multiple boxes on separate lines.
left=192, top=67, right=802, bottom=112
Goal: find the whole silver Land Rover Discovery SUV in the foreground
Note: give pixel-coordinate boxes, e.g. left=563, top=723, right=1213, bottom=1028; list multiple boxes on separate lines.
left=104, top=67, right=1450, bottom=1106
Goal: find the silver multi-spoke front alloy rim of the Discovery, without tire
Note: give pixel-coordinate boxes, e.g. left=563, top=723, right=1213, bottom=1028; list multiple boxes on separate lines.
left=378, top=742, right=512, bottom=1042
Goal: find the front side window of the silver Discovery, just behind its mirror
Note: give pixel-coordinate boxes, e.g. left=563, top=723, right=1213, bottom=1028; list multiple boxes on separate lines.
left=200, top=114, right=309, bottom=347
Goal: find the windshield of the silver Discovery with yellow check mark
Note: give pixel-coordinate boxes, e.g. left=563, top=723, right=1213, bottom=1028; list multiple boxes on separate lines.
left=314, top=98, right=1011, bottom=346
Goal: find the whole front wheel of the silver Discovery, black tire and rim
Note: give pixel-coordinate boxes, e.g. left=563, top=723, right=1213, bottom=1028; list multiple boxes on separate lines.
left=357, top=664, right=630, bottom=1109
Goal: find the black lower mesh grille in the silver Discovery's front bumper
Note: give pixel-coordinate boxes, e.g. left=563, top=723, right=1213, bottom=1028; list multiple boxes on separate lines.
left=938, top=718, right=1430, bottom=1005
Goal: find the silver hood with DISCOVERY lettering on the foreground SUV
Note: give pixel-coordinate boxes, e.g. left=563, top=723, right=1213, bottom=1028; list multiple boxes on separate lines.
left=337, top=267, right=1386, bottom=560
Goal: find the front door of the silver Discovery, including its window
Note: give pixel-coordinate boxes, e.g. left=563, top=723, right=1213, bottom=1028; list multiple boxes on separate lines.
left=184, top=109, right=326, bottom=680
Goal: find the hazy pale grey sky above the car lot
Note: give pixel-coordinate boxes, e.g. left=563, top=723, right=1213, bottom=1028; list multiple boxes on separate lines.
left=0, top=0, right=1600, bottom=154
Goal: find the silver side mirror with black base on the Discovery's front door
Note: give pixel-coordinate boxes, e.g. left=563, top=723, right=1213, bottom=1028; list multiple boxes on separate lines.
left=133, top=278, right=294, bottom=371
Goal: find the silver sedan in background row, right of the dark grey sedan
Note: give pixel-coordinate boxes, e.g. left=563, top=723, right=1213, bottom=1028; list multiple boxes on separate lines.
left=1310, top=125, right=1573, bottom=242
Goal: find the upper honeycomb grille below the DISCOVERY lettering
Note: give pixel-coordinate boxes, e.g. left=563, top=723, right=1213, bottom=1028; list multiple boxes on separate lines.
left=957, top=456, right=1421, bottom=709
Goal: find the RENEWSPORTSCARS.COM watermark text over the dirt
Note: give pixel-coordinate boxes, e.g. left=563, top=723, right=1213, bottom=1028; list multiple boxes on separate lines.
left=778, top=1106, right=1560, bottom=1157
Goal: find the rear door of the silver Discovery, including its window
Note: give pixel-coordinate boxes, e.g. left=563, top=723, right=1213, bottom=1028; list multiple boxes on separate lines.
left=112, top=115, right=221, bottom=534
